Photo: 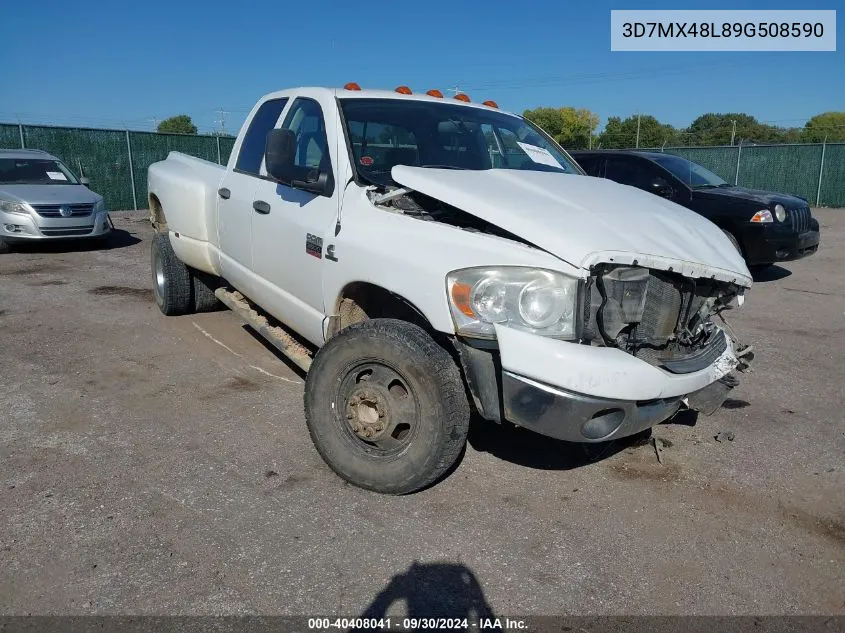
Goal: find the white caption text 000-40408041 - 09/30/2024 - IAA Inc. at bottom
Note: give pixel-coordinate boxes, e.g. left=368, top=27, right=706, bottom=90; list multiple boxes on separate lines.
left=308, top=617, right=526, bottom=631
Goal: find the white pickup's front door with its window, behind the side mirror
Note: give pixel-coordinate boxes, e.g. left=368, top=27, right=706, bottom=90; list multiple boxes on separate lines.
left=252, top=97, right=340, bottom=342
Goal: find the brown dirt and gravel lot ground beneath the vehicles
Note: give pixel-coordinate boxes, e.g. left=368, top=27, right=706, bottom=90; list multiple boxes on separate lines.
left=0, top=209, right=845, bottom=616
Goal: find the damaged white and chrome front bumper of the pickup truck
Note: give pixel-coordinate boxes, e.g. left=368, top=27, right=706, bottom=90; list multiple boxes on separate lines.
left=458, top=326, right=740, bottom=442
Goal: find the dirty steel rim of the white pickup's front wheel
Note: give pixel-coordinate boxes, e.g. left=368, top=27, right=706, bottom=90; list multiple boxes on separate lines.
left=335, top=359, right=420, bottom=458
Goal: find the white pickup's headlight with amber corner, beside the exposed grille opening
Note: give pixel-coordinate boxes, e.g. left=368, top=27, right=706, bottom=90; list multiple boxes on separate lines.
left=446, top=267, right=579, bottom=339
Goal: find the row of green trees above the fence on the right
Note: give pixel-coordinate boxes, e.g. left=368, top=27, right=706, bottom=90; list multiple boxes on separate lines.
left=523, top=107, right=845, bottom=149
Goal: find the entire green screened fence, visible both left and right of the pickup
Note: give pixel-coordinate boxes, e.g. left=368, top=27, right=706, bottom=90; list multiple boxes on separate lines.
left=0, top=123, right=845, bottom=209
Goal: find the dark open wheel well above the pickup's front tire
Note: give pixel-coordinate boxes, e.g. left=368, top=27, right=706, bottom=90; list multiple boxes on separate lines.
left=329, top=281, right=434, bottom=336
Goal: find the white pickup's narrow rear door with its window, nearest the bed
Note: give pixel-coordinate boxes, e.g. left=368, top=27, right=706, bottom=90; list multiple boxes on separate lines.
left=217, top=98, right=288, bottom=289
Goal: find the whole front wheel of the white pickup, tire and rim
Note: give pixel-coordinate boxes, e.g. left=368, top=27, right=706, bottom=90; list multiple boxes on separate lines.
left=305, top=319, right=470, bottom=494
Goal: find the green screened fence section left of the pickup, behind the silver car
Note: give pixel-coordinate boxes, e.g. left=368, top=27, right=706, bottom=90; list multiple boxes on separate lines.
left=0, top=123, right=235, bottom=210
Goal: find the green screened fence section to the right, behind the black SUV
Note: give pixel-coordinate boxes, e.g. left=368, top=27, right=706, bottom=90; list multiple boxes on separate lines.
left=649, top=143, right=845, bottom=207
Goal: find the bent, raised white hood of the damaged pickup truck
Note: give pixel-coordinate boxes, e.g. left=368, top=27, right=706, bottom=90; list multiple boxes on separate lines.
left=391, top=165, right=751, bottom=286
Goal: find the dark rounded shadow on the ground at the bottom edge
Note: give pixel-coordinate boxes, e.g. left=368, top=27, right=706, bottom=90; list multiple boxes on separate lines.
left=351, top=562, right=501, bottom=633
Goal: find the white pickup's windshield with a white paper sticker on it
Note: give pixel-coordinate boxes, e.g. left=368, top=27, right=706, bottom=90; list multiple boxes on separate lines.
left=340, top=98, right=582, bottom=185
